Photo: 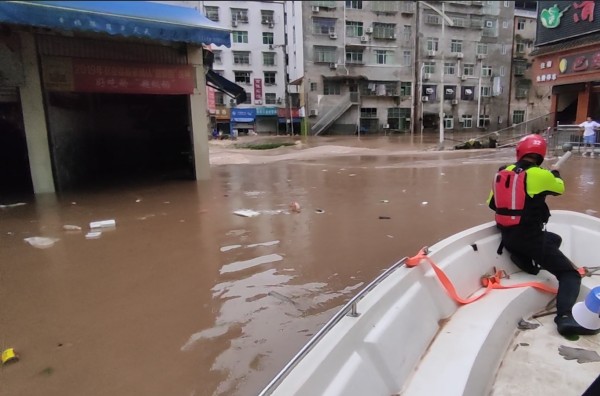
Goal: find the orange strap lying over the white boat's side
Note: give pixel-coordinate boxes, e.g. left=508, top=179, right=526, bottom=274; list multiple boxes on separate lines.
left=406, top=248, right=556, bottom=304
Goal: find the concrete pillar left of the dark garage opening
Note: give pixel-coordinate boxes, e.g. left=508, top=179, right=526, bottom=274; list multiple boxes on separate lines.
left=19, top=32, right=55, bottom=194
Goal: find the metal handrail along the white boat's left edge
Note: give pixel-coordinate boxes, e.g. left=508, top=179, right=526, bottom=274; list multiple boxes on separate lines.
left=258, top=257, right=408, bottom=396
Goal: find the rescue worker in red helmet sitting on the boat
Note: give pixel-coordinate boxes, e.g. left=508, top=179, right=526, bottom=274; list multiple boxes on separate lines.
left=487, top=134, right=598, bottom=335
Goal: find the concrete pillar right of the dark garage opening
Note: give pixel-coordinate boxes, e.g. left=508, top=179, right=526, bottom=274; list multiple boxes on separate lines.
left=188, top=45, right=210, bottom=180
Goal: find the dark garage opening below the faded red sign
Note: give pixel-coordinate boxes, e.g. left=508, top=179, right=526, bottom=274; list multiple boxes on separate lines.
left=47, top=92, right=195, bottom=192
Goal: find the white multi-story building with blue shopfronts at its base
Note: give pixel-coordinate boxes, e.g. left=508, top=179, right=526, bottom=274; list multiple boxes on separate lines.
left=172, top=1, right=292, bottom=134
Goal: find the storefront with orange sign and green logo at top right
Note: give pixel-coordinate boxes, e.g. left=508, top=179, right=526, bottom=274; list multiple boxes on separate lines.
left=532, top=1, right=600, bottom=124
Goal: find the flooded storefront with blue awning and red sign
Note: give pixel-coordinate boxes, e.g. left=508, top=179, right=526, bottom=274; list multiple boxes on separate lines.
left=0, top=1, right=230, bottom=194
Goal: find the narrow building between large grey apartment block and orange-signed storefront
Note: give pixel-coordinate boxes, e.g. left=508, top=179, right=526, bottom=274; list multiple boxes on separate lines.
left=510, top=8, right=552, bottom=124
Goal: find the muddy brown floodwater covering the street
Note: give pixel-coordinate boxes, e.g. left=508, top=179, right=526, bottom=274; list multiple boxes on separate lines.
left=0, top=137, right=600, bottom=396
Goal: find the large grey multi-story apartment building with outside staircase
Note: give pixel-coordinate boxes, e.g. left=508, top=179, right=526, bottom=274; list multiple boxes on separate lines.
left=302, top=1, right=514, bottom=134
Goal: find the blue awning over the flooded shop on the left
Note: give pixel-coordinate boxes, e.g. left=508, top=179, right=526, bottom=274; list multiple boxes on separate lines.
left=0, top=1, right=231, bottom=47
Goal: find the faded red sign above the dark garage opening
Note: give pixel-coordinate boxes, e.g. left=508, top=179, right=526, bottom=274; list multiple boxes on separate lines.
left=73, top=59, right=196, bottom=95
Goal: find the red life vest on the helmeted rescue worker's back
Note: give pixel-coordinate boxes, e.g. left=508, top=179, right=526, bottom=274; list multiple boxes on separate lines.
left=492, top=167, right=527, bottom=227
